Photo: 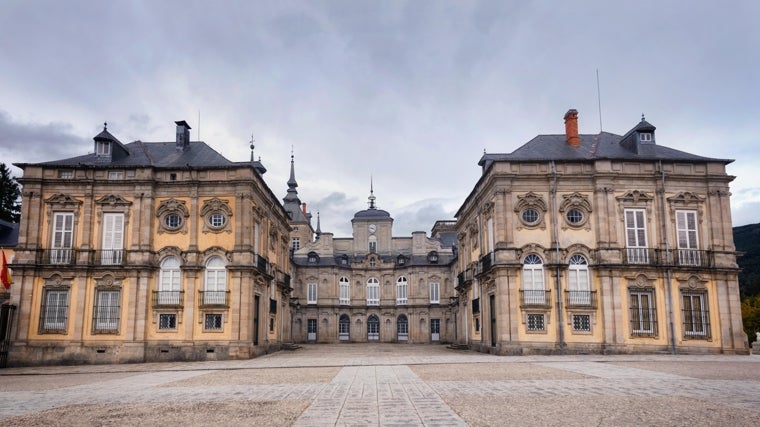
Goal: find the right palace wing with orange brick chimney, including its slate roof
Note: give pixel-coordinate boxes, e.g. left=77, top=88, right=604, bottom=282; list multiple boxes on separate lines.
left=456, top=110, right=748, bottom=354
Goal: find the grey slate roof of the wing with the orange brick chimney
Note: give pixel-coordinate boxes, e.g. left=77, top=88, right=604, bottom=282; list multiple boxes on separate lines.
left=478, top=131, right=733, bottom=167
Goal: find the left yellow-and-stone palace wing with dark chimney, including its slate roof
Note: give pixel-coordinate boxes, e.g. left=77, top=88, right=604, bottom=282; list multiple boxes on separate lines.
left=9, top=122, right=291, bottom=366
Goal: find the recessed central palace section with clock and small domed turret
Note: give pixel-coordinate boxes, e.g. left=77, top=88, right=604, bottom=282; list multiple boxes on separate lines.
left=291, top=189, right=456, bottom=343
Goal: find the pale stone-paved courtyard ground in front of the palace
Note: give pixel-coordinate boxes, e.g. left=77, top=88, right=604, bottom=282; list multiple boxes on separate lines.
left=0, top=344, right=760, bottom=426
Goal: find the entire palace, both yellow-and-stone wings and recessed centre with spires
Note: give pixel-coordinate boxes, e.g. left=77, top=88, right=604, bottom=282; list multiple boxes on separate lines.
left=3, top=110, right=749, bottom=366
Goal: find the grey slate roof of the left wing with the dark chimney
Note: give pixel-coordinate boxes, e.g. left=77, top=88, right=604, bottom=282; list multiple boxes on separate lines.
left=22, top=140, right=236, bottom=168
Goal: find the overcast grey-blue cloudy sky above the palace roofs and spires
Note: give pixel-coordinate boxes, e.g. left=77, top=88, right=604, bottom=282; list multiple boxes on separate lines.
left=0, top=0, right=760, bottom=236
